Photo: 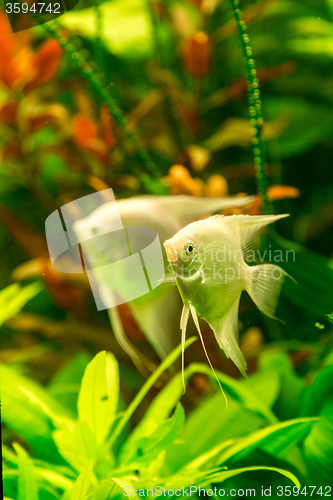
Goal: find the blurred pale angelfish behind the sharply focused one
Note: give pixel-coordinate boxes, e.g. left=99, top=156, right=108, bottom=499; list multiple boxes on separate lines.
left=74, top=196, right=254, bottom=374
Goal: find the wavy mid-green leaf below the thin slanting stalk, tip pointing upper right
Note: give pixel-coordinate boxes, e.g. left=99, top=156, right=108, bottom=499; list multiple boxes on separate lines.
left=120, top=403, right=185, bottom=469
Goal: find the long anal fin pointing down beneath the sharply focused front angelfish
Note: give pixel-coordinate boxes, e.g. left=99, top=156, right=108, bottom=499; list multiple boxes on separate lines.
left=210, top=294, right=247, bottom=377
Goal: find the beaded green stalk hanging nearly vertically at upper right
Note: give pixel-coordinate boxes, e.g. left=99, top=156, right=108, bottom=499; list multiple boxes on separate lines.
left=229, top=0, right=273, bottom=214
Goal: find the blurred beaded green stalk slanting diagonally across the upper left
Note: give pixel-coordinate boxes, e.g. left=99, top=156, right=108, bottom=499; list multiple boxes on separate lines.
left=42, top=23, right=159, bottom=182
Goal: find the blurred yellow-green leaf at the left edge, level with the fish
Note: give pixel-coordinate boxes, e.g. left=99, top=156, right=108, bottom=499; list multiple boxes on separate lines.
left=0, top=282, right=43, bottom=326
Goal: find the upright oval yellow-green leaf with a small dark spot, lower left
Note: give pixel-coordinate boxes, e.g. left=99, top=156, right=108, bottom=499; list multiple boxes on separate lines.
left=78, top=351, right=119, bottom=447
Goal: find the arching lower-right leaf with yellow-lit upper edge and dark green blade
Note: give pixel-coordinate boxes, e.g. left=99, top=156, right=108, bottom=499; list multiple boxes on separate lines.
left=215, top=417, right=317, bottom=463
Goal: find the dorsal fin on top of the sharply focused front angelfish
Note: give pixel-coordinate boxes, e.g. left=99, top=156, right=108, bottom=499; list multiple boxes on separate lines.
left=209, top=214, right=289, bottom=260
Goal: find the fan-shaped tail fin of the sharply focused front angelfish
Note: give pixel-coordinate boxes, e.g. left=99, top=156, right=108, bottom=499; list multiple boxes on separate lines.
left=247, top=264, right=288, bottom=319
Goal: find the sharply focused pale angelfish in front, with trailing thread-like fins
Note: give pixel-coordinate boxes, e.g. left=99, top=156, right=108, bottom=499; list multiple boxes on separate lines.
left=164, top=214, right=288, bottom=392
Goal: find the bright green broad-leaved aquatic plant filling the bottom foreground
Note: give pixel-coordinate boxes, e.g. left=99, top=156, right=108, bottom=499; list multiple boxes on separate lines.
left=0, top=344, right=318, bottom=500
